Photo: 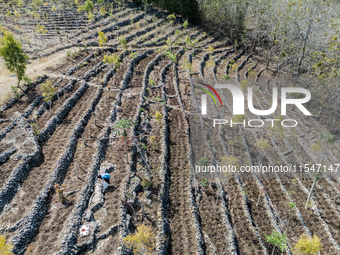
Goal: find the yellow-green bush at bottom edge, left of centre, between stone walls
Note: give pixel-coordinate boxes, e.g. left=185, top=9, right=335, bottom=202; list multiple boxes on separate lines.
left=123, top=225, right=156, bottom=255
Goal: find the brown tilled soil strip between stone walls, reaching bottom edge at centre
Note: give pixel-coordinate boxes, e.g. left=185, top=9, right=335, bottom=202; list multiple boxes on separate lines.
left=169, top=110, right=197, bottom=254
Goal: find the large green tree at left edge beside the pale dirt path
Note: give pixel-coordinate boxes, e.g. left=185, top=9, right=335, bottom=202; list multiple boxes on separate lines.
left=0, top=30, right=28, bottom=90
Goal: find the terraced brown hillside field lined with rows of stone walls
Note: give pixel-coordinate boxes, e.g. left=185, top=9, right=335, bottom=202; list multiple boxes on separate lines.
left=0, top=0, right=340, bottom=255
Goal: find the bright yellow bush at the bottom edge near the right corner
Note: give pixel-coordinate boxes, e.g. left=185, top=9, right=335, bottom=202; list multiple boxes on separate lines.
left=293, top=233, right=321, bottom=255
